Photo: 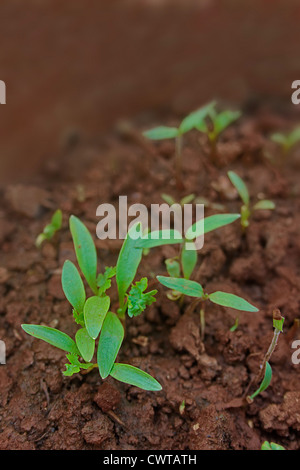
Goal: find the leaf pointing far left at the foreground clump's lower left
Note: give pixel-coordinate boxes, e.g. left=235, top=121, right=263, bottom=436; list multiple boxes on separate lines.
left=21, top=324, right=79, bottom=354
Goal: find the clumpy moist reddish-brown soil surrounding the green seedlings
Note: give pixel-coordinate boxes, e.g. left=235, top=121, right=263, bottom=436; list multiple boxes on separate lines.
left=0, top=102, right=300, bottom=450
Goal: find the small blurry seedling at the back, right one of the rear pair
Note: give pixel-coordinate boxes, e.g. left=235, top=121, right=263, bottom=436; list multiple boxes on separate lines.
left=196, top=106, right=241, bottom=148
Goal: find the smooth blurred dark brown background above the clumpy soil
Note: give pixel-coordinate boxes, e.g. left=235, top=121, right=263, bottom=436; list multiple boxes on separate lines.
left=0, top=0, right=300, bottom=183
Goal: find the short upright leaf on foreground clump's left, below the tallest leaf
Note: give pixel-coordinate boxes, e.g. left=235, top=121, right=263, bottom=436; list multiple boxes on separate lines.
left=61, top=260, right=86, bottom=313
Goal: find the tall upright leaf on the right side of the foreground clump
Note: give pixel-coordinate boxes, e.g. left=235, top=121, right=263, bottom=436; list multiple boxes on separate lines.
left=116, top=223, right=143, bottom=308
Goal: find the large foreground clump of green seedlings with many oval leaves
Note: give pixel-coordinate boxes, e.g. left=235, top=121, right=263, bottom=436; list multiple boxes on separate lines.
left=22, top=216, right=161, bottom=391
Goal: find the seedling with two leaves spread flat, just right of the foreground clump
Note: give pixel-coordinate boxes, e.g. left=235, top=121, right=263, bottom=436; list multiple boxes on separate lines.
left=157, top=276, right=258, bottom=339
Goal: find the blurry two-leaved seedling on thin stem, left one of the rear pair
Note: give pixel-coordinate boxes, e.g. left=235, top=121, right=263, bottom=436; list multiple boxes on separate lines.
left=143, top=102, right=215, bottom=189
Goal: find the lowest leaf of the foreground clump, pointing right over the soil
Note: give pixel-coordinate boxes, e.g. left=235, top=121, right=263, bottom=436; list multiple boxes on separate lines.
left=110, top=363, right=162, bottom=392
